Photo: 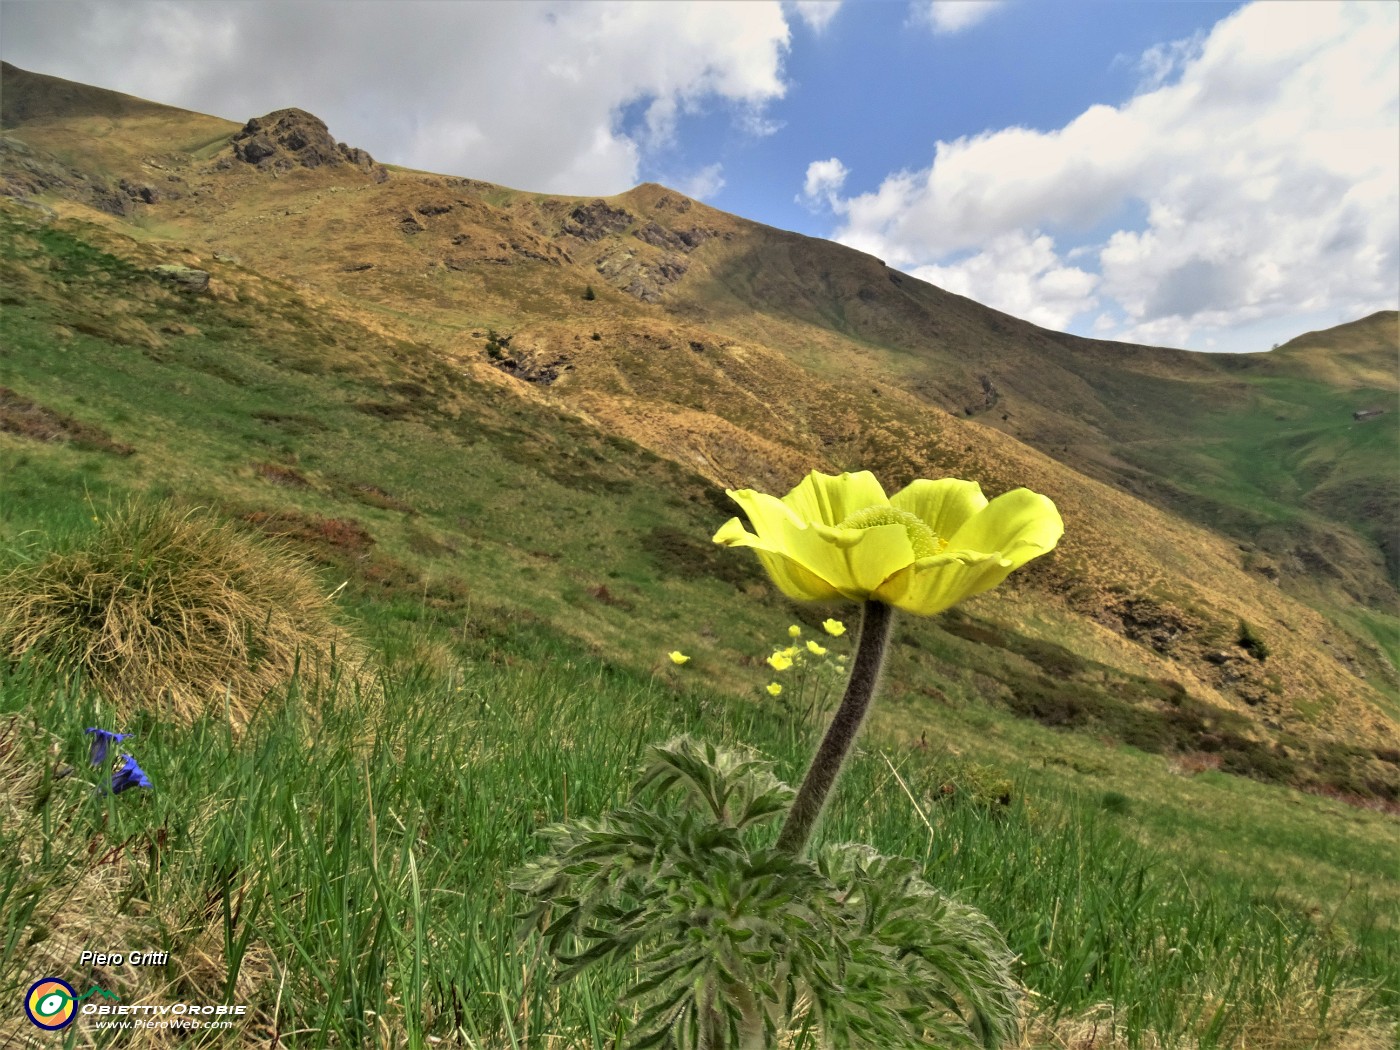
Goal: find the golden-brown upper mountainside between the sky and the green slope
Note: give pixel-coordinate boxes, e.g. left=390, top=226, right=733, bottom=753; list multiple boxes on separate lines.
left=0, top=66, right=1400, bottom=797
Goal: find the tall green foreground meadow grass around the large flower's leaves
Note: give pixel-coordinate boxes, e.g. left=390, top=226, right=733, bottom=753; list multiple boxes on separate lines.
left=0, top=579, right=1400, bottom=1047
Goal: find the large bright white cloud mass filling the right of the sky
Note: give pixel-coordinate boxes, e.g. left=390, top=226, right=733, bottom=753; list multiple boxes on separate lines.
left=808, top=3, right=1400, bottom=350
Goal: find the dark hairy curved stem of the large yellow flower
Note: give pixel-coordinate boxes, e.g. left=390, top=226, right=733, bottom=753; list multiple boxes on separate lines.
left=777, top=601, right=895, bottom=857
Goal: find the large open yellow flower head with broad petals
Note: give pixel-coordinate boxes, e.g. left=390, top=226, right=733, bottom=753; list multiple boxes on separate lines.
left=714, top=470, right=1064, bottom=616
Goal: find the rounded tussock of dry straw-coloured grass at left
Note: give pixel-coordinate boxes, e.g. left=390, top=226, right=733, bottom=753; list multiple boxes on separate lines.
left=0, top=504, right=353, bottom=724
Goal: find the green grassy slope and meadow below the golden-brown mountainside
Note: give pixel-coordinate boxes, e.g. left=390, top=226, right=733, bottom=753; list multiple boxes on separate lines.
left=0, top=201, right=1400, bottom=1050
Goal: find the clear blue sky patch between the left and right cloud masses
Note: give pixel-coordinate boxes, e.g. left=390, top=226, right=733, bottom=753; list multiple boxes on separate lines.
left=635, top=0, right=1240, bottom=237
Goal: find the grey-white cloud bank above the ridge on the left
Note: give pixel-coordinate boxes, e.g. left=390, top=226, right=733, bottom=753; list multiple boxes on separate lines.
left=4, top=0, right=790, bottom=193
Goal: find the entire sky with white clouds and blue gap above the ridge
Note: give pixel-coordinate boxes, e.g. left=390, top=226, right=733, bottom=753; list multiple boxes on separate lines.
left=0, top=0, right=1400, bottom=351
